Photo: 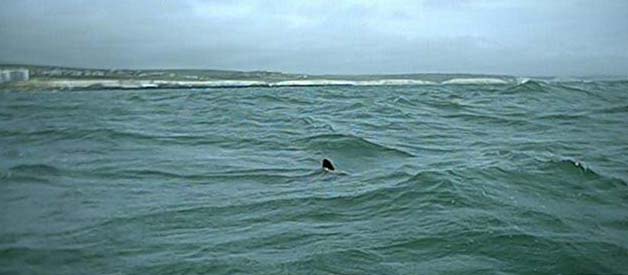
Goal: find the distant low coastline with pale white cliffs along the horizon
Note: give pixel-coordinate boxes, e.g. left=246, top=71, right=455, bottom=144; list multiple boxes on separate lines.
left=0, top=64, right=517, bottom=91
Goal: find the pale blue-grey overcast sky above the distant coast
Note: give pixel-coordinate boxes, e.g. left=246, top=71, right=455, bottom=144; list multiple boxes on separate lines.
left=0, top=0, right=628, bottom=76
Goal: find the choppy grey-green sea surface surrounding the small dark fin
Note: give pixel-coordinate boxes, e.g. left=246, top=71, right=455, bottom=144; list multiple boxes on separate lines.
left=0, top=81, right=628, bottom=274
